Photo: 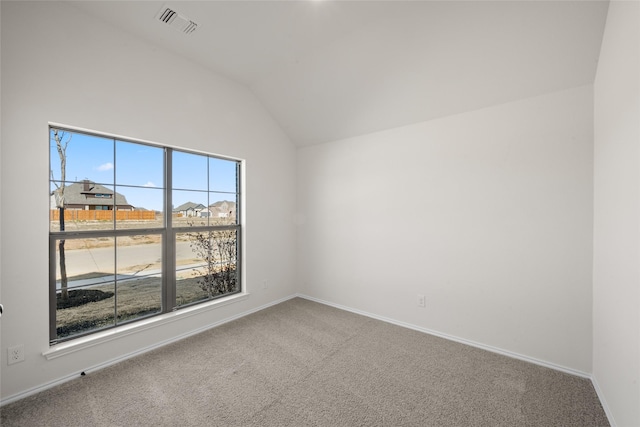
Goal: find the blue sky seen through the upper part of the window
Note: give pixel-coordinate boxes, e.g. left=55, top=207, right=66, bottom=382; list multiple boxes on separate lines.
left=49, top=131, right=236, bottom=211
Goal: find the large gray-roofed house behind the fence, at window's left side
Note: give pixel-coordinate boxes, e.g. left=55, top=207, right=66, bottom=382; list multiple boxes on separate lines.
left=51, top=179, right=134, bottom=211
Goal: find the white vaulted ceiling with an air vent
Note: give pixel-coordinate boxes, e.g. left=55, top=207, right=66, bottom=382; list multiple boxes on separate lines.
left=71, top=0, right=608, bottom=146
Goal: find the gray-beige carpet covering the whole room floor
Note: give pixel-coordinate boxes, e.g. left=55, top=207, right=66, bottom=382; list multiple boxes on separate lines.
left=0, top=298, right=609, bottom=427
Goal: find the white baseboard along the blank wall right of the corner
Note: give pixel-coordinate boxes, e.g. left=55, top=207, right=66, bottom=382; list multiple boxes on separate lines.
left=296, top=294, right=591, bottom=379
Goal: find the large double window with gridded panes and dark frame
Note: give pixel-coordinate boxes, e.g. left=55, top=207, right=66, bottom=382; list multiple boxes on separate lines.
left=49, top=127, right=241, bottom=344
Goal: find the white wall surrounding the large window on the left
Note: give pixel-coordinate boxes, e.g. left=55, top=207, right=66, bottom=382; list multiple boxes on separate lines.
left=0, top=2, right=295, bottom=399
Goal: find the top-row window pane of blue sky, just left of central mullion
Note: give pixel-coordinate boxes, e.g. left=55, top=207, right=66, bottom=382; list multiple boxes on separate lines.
left=116, top=141, right=164, bottom=188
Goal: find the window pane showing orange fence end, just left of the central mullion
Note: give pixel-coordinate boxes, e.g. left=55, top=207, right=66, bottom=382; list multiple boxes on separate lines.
left=116, top=186, right=164, bottom=229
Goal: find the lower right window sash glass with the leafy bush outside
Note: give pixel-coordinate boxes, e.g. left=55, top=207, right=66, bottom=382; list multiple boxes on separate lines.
left=176, top=230, right=240, bottom=306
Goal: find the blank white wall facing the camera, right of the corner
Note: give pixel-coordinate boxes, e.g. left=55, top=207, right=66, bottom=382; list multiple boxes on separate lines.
left=298, top=86, right=593, bottom=373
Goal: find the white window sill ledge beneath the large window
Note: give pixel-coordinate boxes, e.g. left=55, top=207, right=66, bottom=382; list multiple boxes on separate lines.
left=42, top=292, right=249, bottom=360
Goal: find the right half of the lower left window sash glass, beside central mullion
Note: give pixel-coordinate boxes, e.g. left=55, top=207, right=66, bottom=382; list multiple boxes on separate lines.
left=116, top=234, right=162, bottom=323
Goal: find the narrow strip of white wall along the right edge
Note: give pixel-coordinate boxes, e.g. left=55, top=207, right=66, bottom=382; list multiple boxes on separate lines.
left=593, top=1, right=640, bottom=426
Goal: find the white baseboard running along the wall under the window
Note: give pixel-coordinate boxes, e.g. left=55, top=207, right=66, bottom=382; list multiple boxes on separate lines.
left=0, top=294, right=297, bottom=407
